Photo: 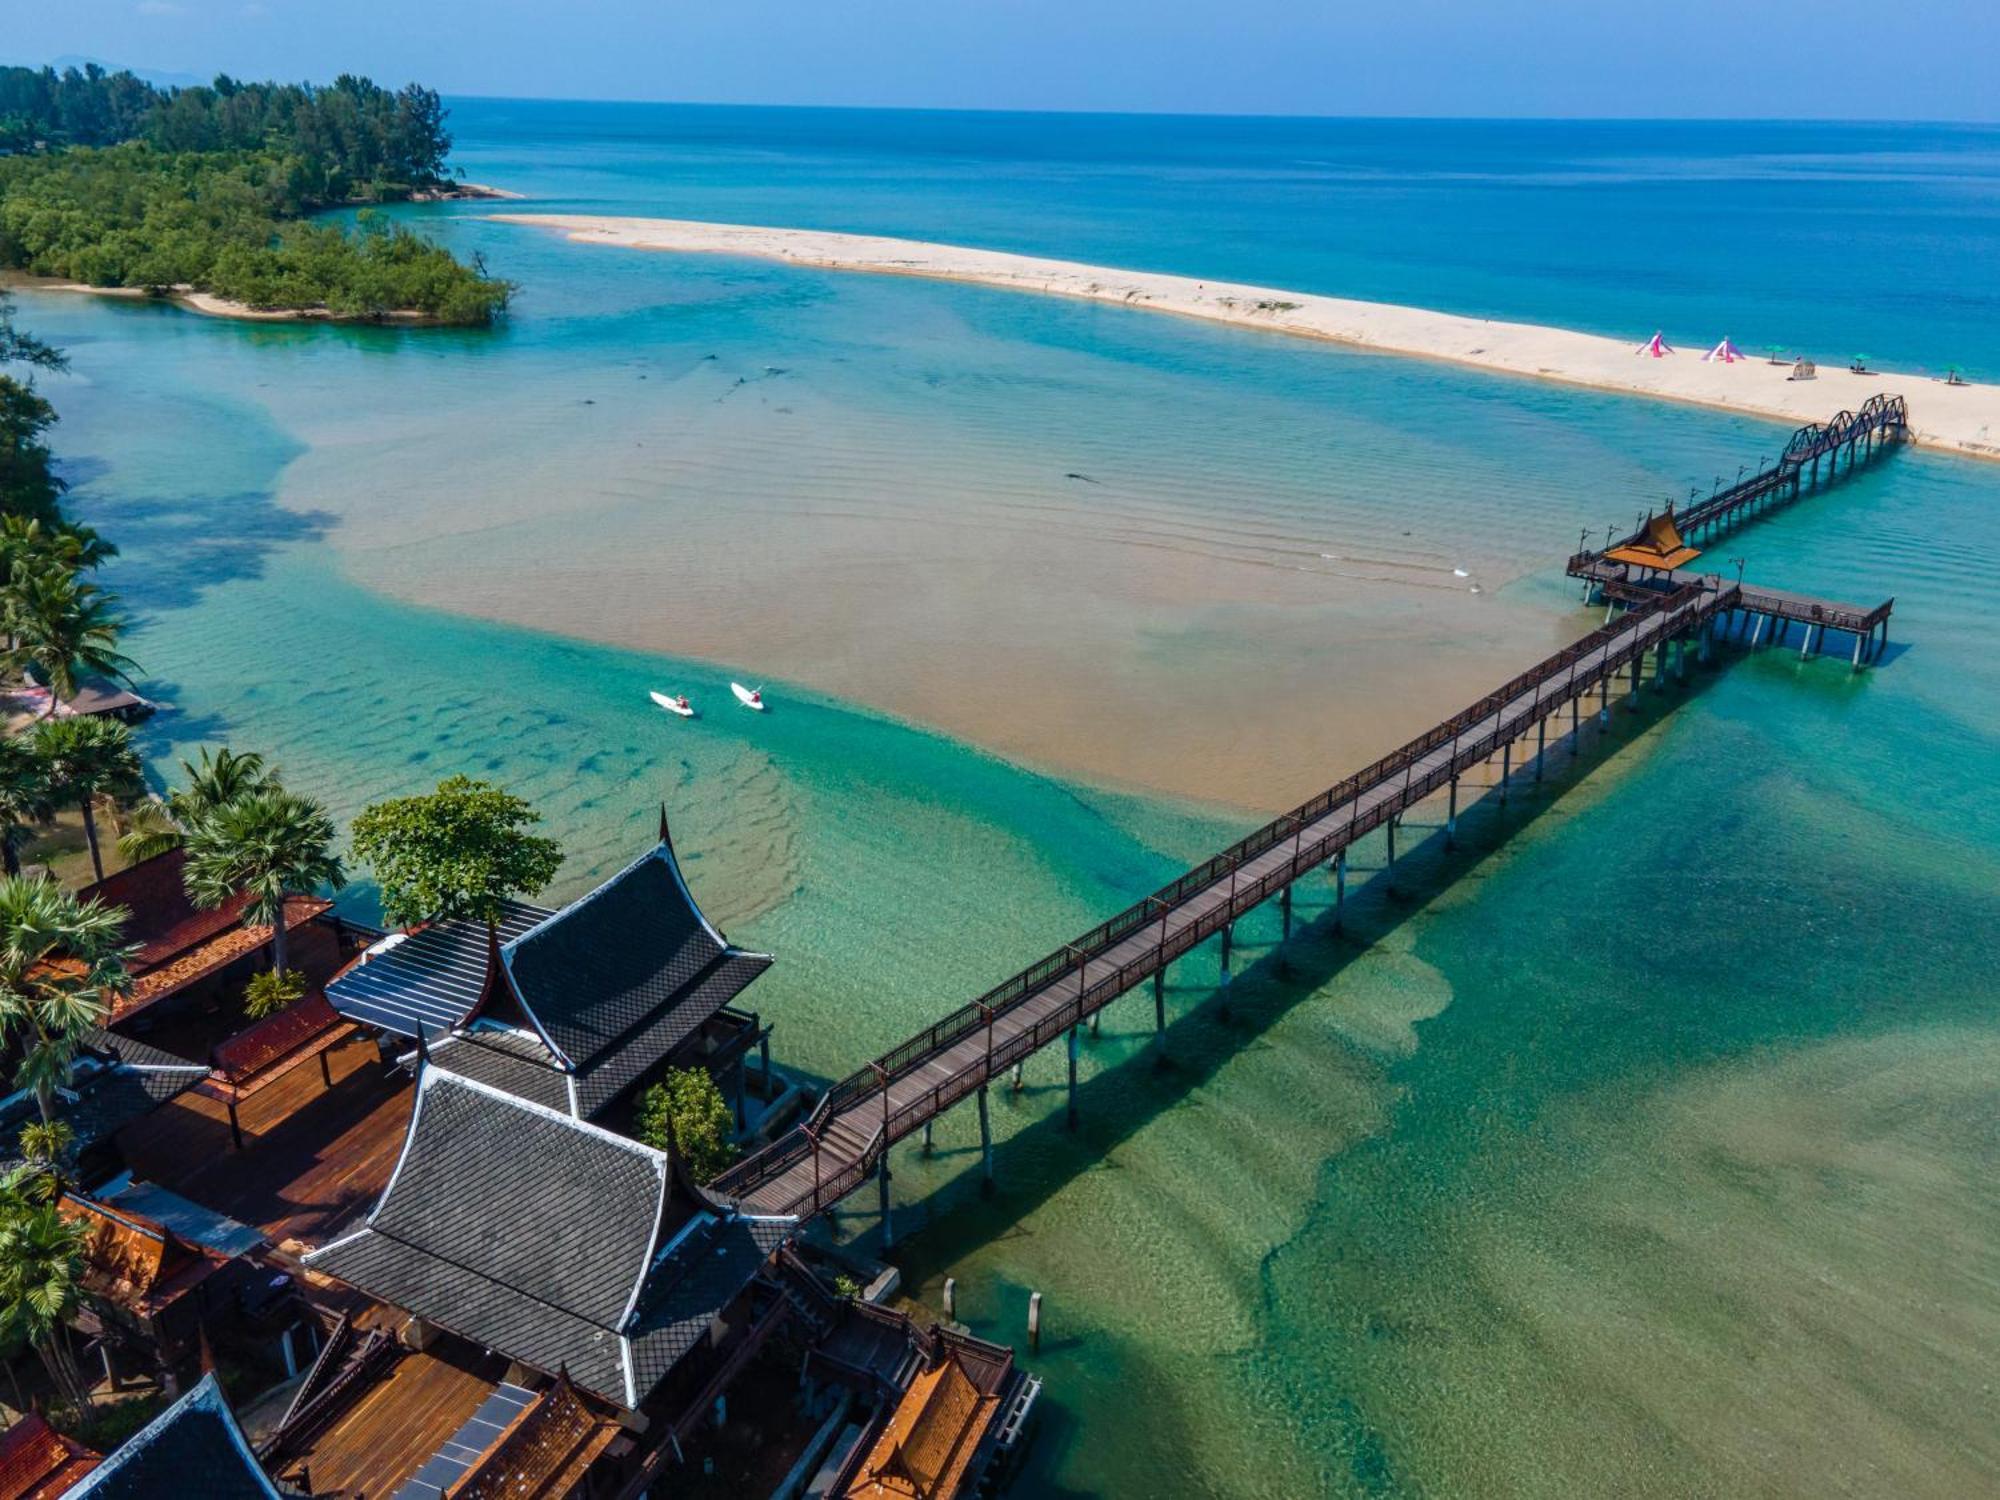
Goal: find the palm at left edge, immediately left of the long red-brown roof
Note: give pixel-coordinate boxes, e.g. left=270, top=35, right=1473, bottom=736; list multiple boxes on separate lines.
left=0, top=876, right=130, bottom=1124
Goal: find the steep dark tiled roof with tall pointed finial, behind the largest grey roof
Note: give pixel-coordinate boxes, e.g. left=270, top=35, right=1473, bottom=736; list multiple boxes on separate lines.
left=500, top=844, right=754, bottom=1070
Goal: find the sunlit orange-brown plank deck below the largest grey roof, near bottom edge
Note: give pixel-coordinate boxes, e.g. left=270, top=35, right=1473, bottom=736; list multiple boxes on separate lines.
left=284, top=1340, right=508, bottom=1500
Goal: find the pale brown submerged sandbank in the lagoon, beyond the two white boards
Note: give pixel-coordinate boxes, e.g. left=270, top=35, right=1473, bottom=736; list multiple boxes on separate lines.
left=312, top=350, right=1592, bottom=824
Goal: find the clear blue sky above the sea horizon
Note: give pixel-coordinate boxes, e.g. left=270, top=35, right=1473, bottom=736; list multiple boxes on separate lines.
left=11, top=0, right=2000, bottom=120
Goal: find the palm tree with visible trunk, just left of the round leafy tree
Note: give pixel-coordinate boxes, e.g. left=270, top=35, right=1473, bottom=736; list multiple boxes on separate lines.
left=182, top=786, right=348, bottom=974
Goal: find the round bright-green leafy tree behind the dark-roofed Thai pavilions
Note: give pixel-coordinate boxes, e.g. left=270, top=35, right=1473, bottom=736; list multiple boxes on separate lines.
left=354, top=776, right=562, bottom=926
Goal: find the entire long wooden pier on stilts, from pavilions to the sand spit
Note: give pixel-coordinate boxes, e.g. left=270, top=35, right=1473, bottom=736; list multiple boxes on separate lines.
left=714, top=398, right=1904, bottom=1240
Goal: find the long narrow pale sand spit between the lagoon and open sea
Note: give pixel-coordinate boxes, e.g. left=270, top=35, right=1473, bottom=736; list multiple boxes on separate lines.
left=486, top=214, right=2000, bottom=460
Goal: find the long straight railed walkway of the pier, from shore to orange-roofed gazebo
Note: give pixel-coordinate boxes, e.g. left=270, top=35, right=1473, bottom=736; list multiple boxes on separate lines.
left=716, top=580, right=1736, bottom=1216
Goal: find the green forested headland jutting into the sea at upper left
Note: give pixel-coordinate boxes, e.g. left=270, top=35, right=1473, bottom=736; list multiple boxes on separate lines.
left=0, top=68, right=510, bottom=324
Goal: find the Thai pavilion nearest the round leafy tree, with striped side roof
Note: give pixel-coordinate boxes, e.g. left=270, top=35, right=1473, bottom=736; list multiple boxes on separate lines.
left=326, top=816, right=772, bottom=1120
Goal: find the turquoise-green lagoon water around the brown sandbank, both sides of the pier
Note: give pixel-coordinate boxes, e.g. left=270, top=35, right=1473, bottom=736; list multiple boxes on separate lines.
left=15, top=108, right=2000, bottom=1496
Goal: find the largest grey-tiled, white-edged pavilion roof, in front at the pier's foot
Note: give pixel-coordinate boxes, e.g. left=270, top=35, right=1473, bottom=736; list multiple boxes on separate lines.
left=304, top=1064, right=798, bottom=1430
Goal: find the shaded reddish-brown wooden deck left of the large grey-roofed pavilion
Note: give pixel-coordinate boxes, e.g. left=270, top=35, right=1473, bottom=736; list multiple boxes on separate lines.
left=120, top=1040, right=414, bottom=1252
